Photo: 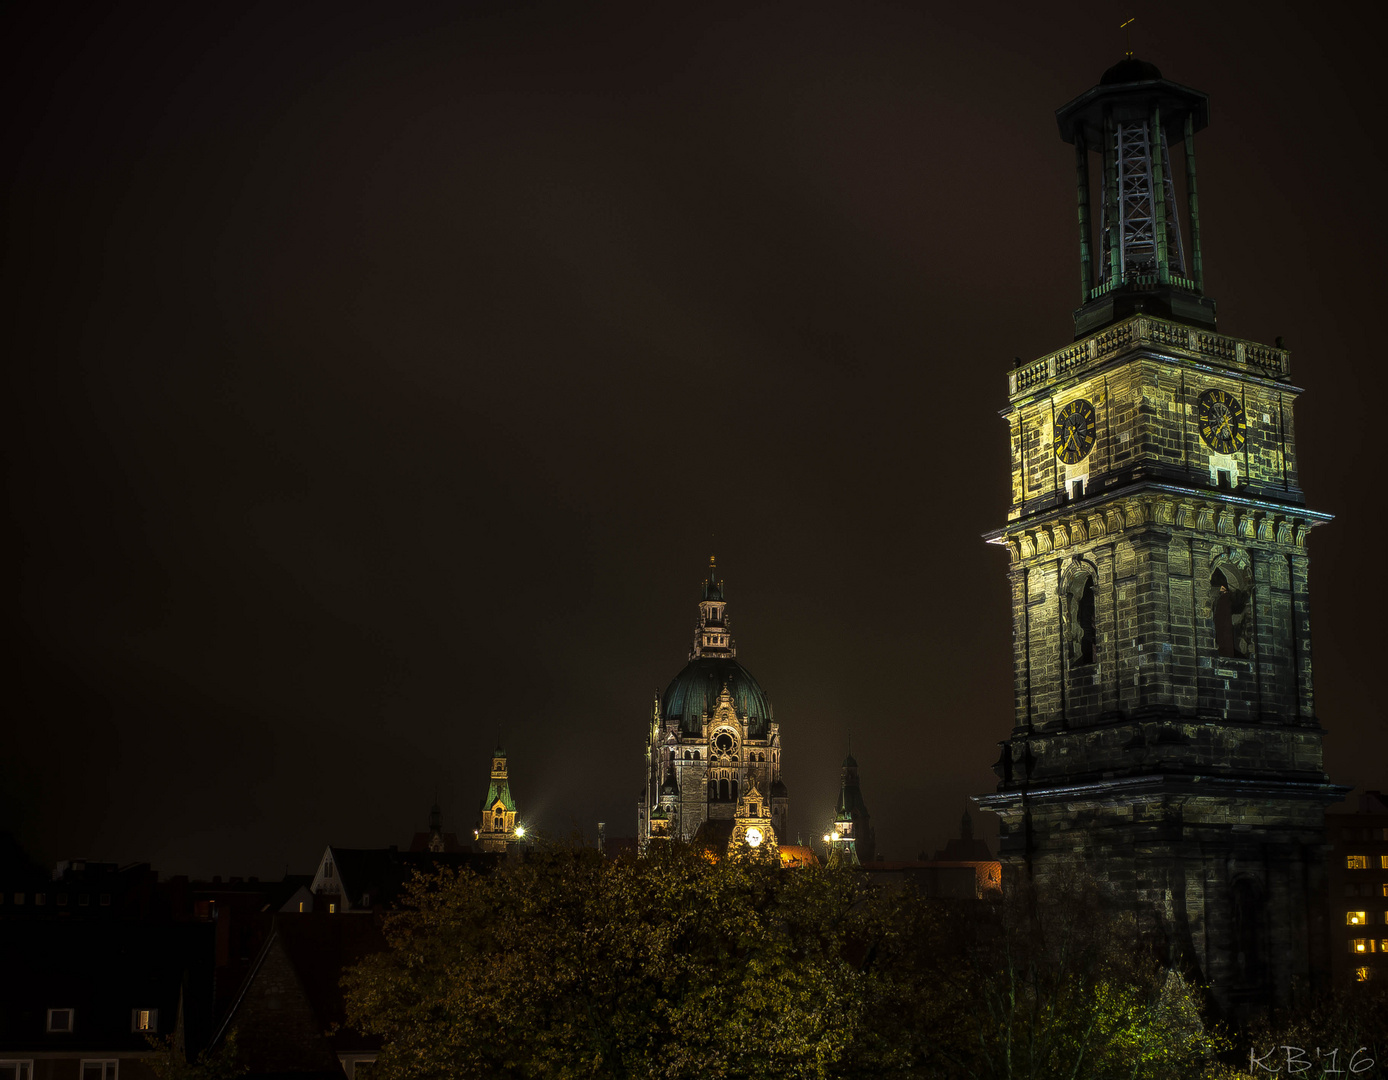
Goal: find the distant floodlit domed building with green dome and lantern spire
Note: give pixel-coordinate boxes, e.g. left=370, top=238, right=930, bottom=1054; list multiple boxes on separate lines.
left=637, top=558, right=790, bottom=850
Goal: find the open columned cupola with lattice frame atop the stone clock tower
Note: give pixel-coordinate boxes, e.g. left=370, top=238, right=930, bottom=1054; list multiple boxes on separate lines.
left=1055, top=56, right=1215, bottom=339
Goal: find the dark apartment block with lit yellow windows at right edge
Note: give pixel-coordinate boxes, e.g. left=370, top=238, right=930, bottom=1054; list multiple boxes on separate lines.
left=1326, top=791, right=1388, bottom=984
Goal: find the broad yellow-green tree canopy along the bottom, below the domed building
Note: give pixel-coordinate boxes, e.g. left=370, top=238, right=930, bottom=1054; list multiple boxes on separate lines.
left=344, top=844, right=1224, bottom=1080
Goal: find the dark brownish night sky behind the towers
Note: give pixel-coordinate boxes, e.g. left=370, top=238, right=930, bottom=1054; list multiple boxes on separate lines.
left=0, top=1, right=1388, bottom=876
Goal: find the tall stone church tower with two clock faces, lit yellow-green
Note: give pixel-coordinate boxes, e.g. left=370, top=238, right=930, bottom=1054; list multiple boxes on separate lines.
left=977, top=57, right=1345, bottom=1018
